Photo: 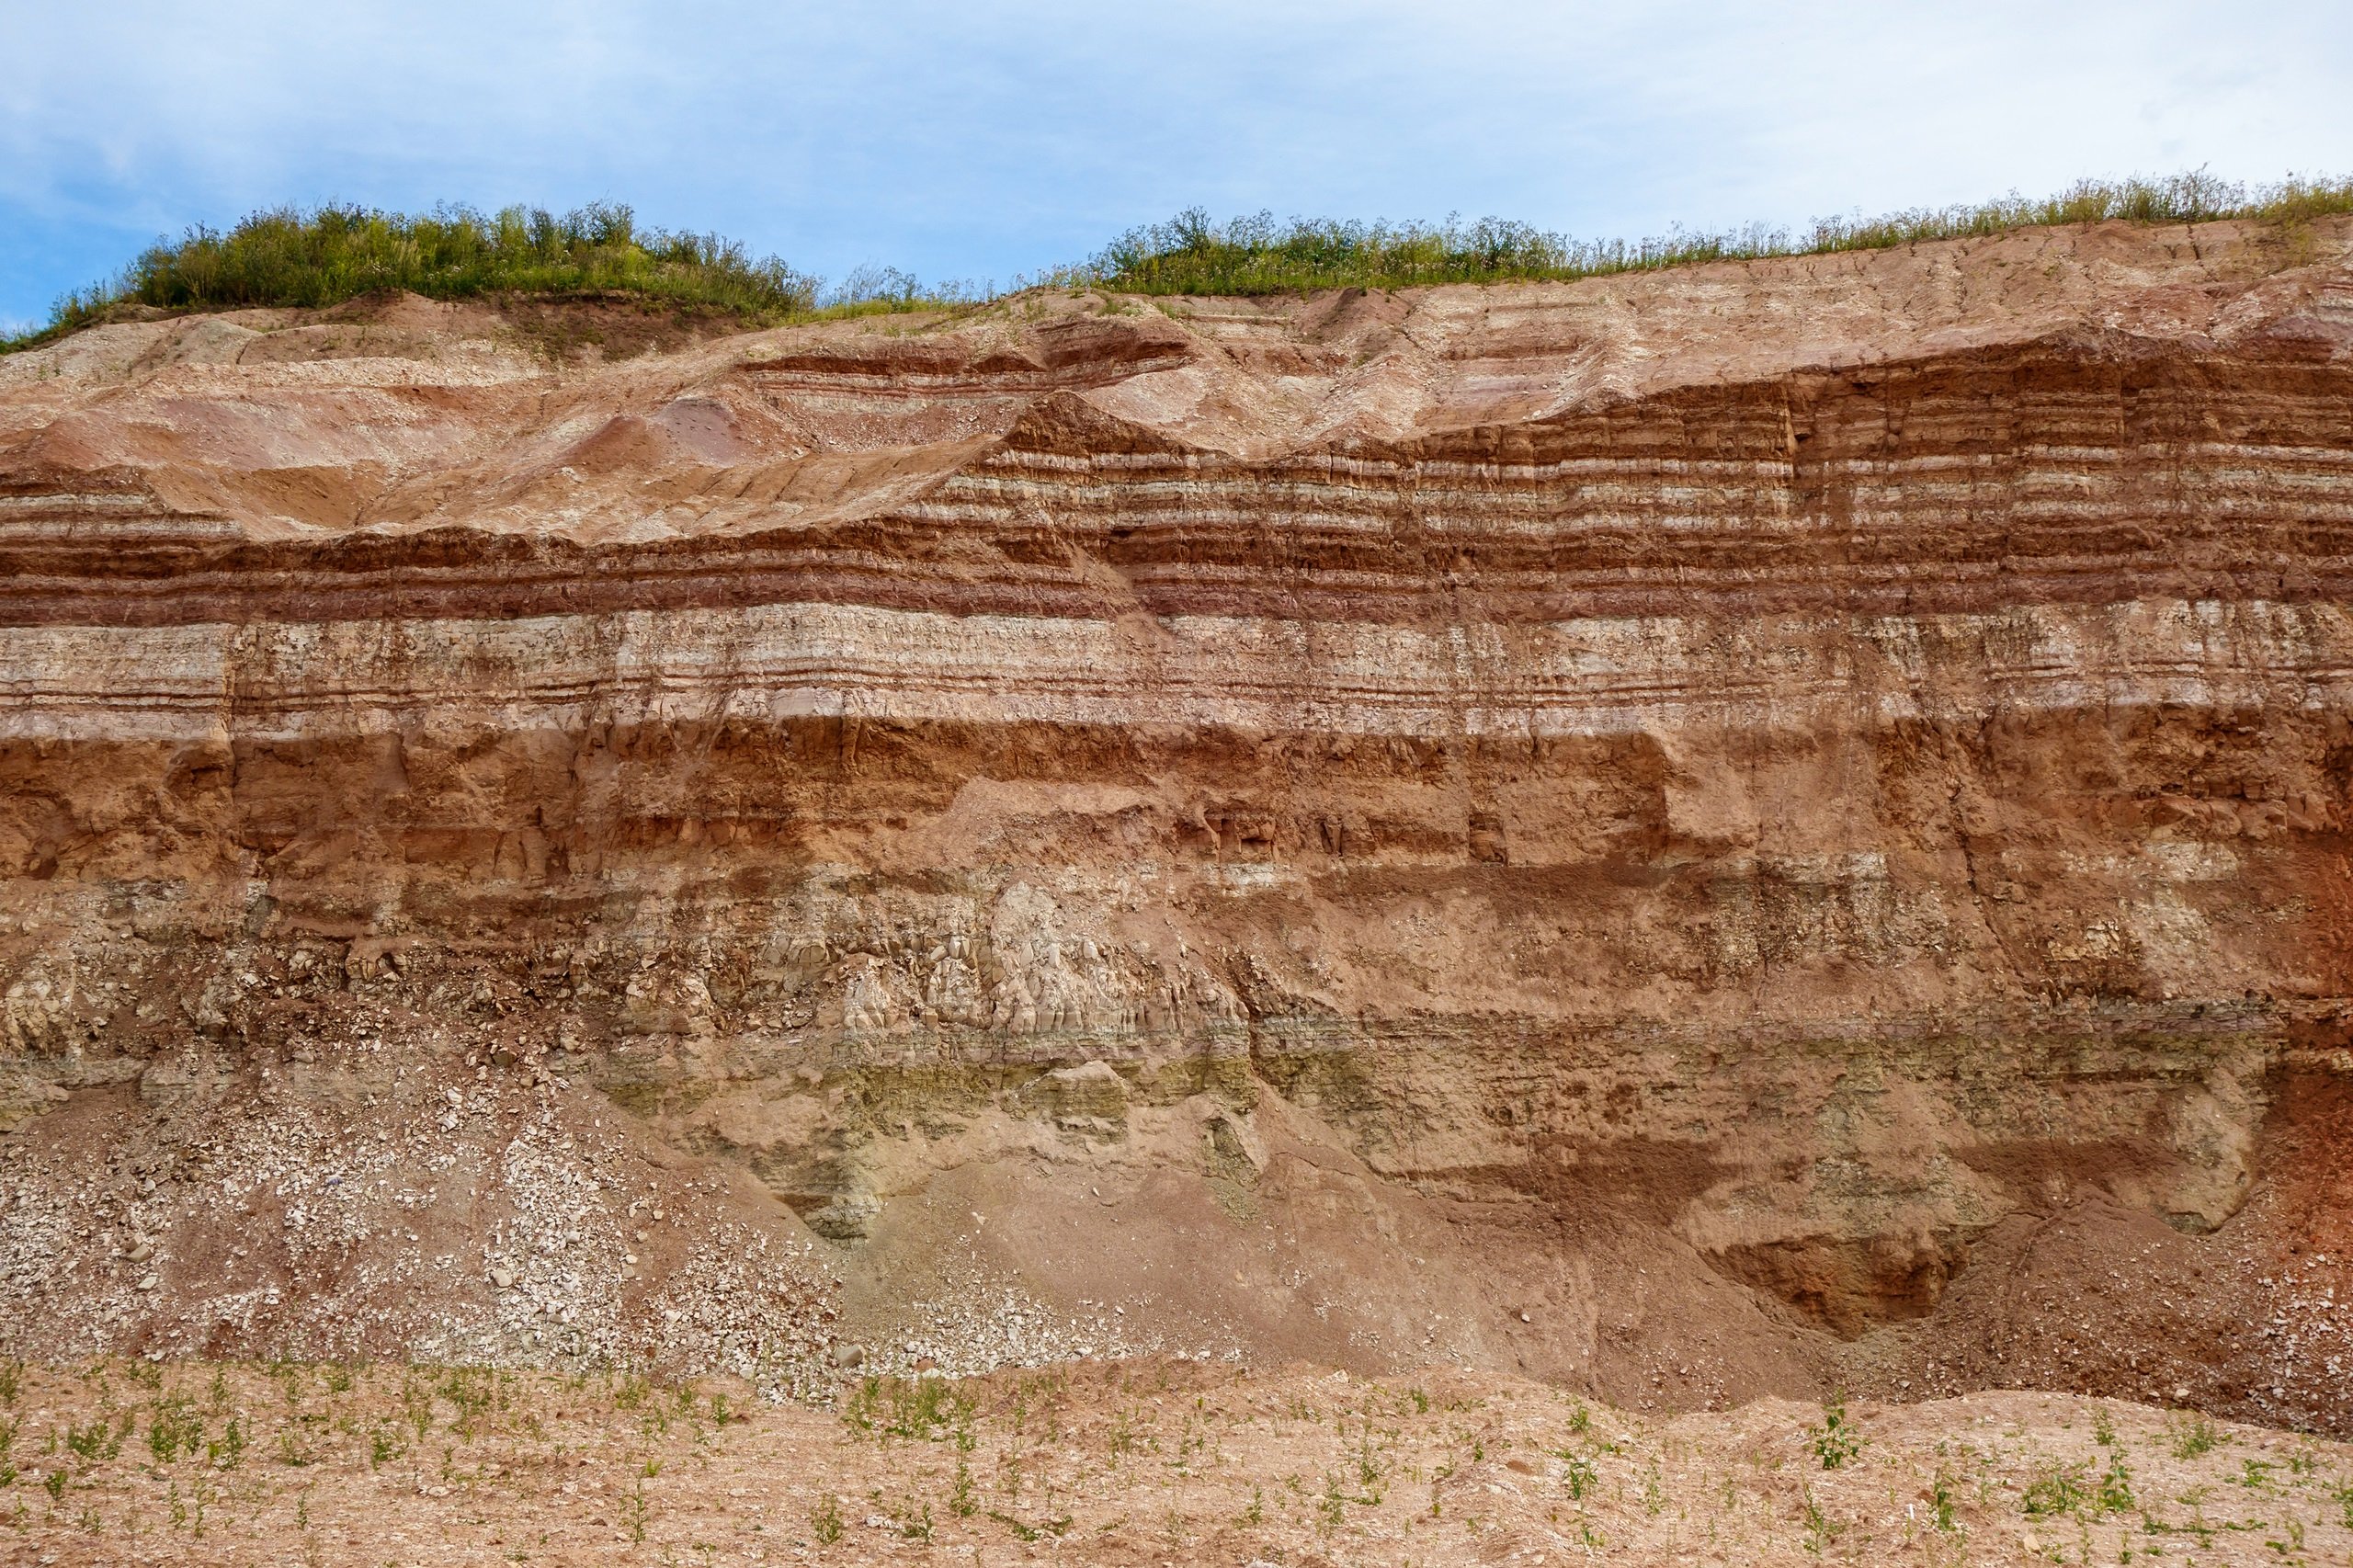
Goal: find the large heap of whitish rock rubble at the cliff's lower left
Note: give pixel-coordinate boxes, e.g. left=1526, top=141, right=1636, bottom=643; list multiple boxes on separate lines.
left=0, top=1026, right=837, bottom=1399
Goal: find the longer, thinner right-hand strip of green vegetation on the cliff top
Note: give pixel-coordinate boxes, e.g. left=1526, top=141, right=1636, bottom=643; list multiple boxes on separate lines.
left=1085, top=175, right=2353, bottom=294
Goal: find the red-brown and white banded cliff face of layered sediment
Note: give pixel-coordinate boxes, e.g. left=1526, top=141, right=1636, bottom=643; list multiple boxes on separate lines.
left=0, top=222, right=2353, bottom=1425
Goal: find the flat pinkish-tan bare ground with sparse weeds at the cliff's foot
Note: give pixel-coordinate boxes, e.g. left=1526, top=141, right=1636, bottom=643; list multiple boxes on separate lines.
left=0, top=1358, right=2353, bottom=1565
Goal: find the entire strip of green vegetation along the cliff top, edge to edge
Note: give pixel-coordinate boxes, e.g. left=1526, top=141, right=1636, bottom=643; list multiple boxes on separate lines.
left=0, top=172, right=2353, bottom=353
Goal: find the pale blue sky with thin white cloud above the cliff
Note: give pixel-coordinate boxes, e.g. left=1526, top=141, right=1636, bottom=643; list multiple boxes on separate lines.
left=0, top=0, right=2353, bottom=324
